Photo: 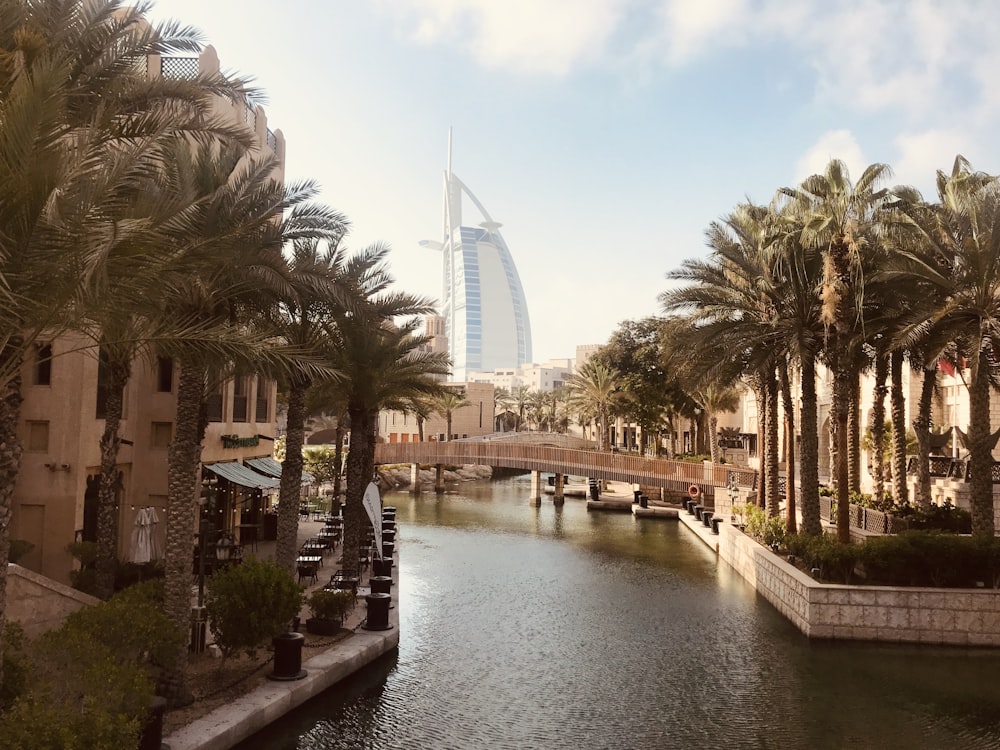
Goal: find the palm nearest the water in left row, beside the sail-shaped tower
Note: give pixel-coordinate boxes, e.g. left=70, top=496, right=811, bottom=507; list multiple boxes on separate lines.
left=327, top=292, right=450, bottom=569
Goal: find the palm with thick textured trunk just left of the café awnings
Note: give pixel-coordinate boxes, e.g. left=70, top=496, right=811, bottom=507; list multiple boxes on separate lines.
left=159, top=144, right=343, bottom=664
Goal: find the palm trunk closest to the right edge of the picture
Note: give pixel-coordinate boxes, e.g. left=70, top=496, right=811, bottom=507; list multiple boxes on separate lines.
left=965, top=347, right=997, bottom=537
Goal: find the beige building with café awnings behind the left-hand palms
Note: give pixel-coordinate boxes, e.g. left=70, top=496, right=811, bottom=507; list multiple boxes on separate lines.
left=10, top=47, right=285, bottom=582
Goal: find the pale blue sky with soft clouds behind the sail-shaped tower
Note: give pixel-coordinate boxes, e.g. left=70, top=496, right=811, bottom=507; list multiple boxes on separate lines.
left=145, top=0, right=1000, bottom=363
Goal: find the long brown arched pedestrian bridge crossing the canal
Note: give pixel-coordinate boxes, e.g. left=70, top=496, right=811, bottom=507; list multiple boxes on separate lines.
left=375, top=433, right=757, bottom=499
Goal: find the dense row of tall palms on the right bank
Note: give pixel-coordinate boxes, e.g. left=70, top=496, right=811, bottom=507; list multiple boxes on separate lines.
left=660, top=156, right=1000, bottom=541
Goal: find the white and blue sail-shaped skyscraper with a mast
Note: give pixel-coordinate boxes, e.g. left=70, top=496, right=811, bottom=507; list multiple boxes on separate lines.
left=421, top=130, right=531, bottom=382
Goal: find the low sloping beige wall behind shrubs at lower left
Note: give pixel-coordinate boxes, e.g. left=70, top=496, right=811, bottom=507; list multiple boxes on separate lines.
left=6, top=563, right=100, bottom=638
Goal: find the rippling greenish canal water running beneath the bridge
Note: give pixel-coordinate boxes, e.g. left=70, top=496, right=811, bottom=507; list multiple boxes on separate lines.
left=240, top=477, right=1000, bottom=750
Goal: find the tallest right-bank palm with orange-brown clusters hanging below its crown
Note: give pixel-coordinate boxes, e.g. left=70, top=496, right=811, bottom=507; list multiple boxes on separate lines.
left=781, top=159, right=893, bottom=543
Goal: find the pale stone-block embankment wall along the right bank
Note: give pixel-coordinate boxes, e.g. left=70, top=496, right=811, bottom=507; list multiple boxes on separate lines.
left=719, top=524, right=1000, bottom=646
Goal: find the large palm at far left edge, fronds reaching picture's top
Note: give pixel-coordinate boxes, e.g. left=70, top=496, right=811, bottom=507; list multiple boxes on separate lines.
left=0, top=0, right=254, bottom=672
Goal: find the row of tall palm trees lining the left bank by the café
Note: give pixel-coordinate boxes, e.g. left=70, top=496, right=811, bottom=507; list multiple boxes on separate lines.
left=0, top=0, right=447, bottom=704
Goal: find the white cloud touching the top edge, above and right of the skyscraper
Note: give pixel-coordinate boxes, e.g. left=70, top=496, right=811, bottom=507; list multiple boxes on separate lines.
left=381, top=0, right=629, bottom=76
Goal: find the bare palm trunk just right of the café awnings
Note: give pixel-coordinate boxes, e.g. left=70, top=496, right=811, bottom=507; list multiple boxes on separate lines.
left=274, top=376, right=310, bottom=573
